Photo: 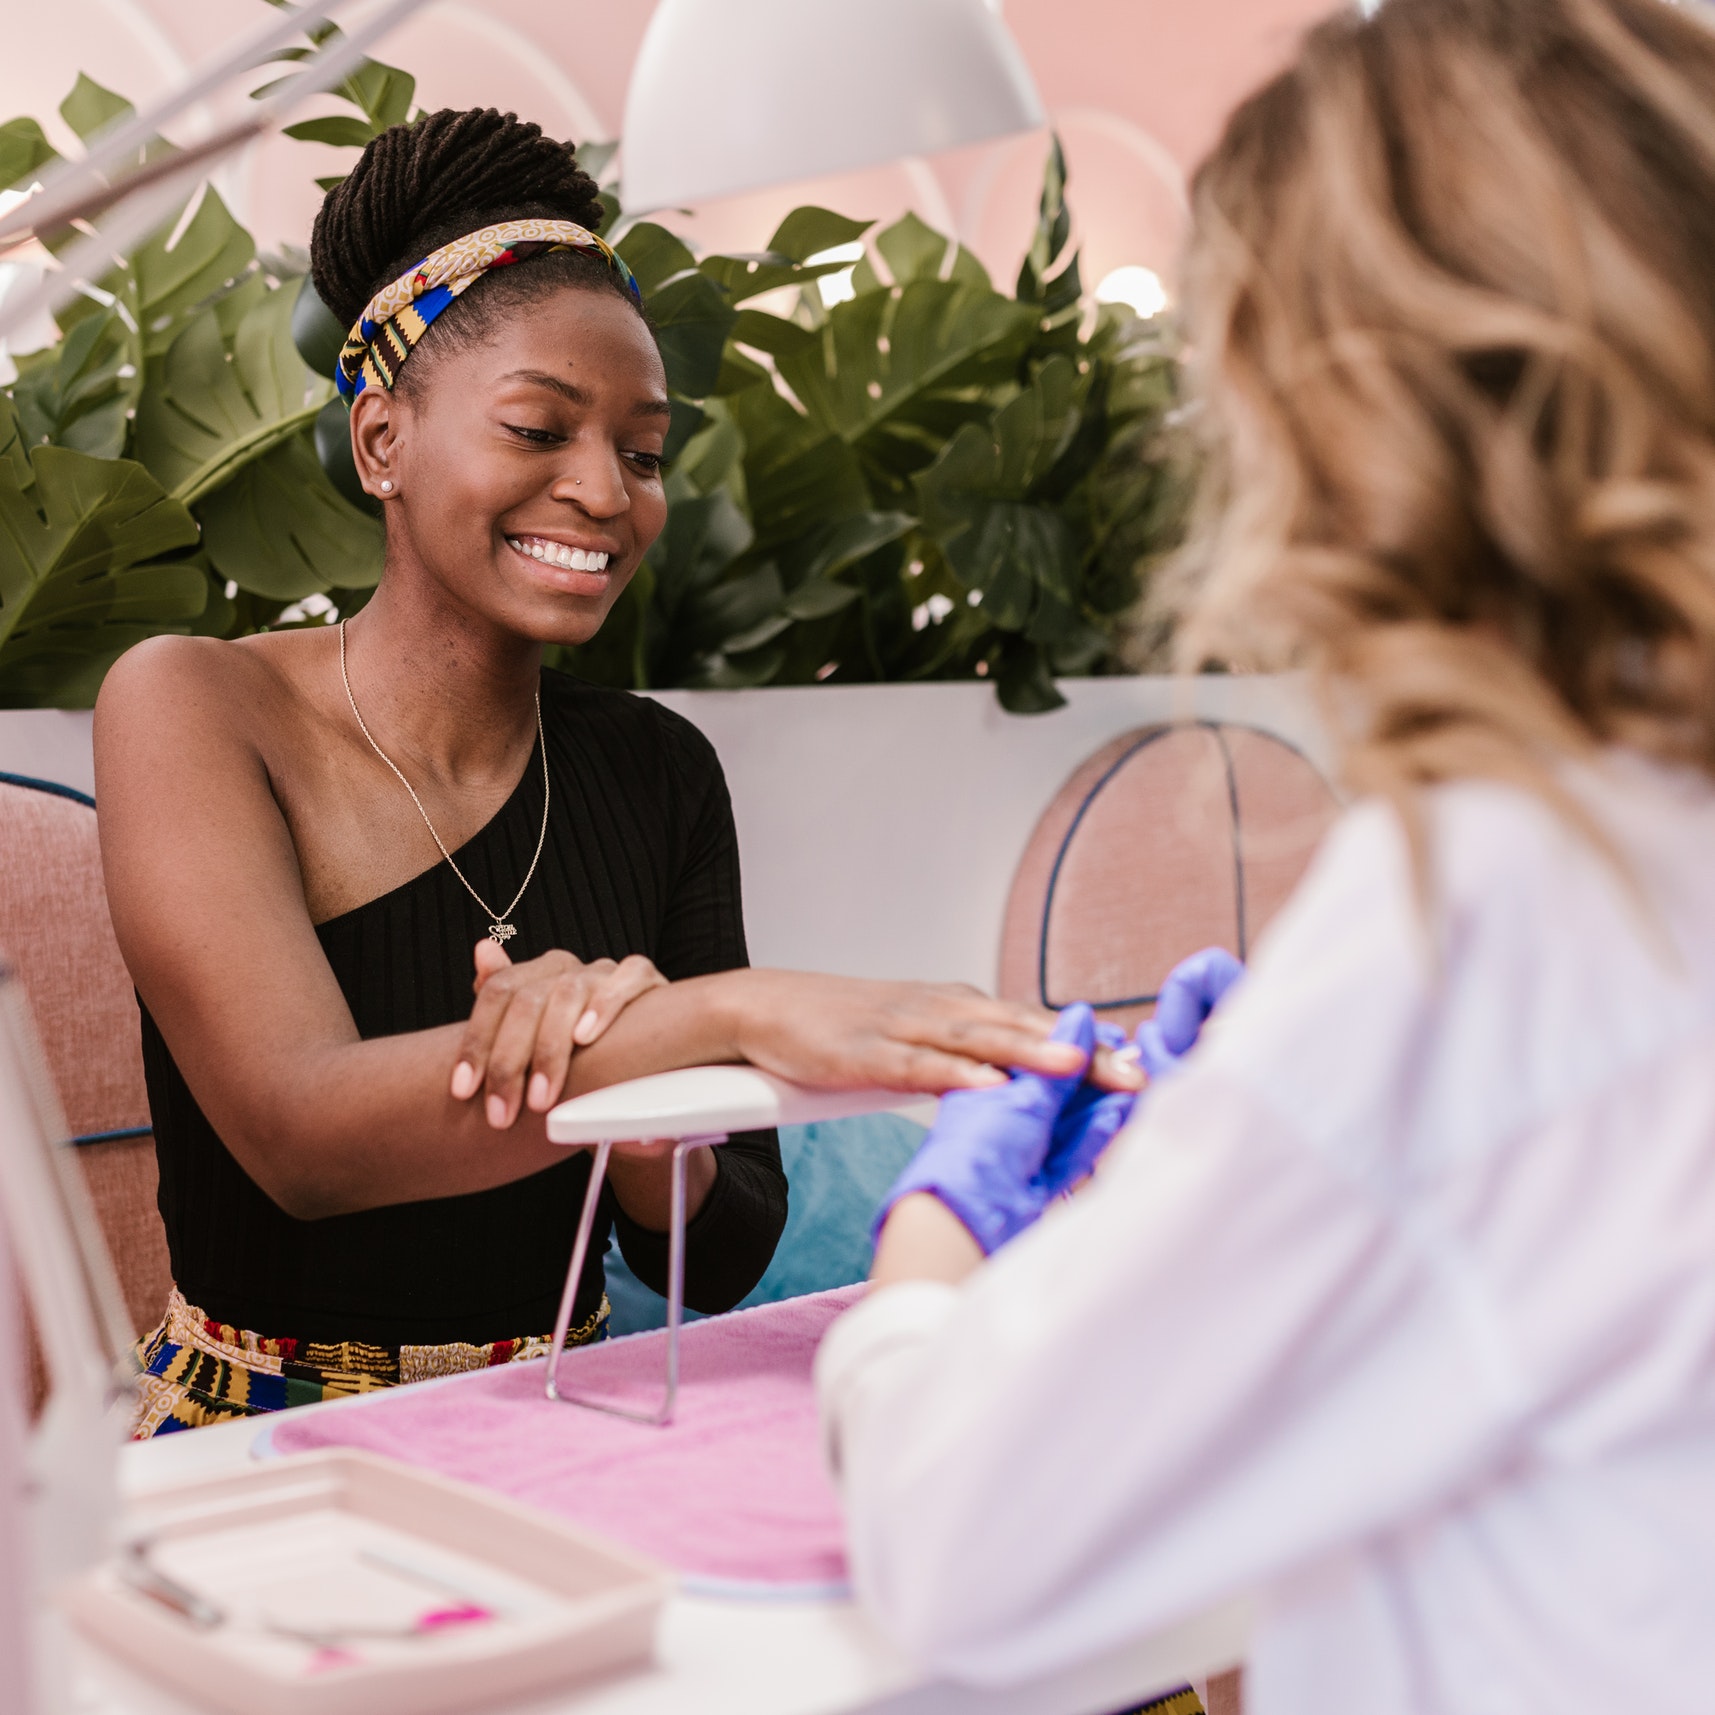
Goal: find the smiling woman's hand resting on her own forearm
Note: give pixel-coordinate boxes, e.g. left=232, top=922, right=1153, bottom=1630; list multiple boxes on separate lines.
left=453, top=940, right=667, bottom=1130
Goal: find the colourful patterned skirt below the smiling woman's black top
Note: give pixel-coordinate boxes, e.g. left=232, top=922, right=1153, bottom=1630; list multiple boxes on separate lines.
left=132, top=1290, right=609, bottom=1441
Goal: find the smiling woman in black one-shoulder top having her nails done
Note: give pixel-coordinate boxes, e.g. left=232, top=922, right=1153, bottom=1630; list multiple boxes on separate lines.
left=96, top=110, right=1127, bottom=1434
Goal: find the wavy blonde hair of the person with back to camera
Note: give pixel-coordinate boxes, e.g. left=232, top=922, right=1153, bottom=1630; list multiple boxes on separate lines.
left=1176, top=0, right=1715, bottom=832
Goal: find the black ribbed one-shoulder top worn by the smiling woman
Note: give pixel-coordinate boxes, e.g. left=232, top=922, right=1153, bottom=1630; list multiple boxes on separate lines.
left=142, top=672, right=785, bottom=1346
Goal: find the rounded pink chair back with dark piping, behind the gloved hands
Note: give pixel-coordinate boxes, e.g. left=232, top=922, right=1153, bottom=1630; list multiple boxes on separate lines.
left=1000, top=722, right=1338, bottom=1029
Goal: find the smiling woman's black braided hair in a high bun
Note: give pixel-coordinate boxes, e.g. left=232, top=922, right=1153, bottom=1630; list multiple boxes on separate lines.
left=310, top=108, right=629, bottom=382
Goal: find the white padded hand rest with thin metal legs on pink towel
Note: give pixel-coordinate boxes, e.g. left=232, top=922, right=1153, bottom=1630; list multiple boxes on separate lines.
left=544, top=1065, right=935, bottom=1423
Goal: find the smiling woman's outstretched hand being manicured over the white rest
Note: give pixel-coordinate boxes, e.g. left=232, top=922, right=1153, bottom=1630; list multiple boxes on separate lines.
left=716, top=971, right=1144, bottom=1094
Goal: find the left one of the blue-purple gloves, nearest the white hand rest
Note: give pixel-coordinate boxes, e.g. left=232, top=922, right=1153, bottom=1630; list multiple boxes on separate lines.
left=875, top=1005, right=1097, bottom=1255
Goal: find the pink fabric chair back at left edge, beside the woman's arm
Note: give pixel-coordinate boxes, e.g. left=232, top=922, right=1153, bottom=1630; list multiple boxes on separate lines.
left=0, top=773, right=173, bottom=1351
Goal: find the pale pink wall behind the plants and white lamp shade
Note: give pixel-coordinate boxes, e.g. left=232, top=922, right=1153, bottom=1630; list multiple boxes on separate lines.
left=0, top=0, right=1329, bottom=293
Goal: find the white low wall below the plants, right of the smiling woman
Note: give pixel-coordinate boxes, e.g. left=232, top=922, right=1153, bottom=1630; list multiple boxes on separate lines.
left=657, top=677, right=1326, bottom=990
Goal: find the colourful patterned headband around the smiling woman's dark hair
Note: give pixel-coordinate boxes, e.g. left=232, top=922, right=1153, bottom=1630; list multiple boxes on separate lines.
left=333, top=220, right=643, bottom=405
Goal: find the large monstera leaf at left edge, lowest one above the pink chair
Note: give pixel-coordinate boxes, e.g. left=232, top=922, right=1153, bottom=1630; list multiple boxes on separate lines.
left=0, top=412, right=209, bottom=708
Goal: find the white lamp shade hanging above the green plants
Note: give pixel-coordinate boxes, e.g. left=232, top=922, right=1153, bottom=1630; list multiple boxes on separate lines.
left=623, top=0, right=1044, bottom=213
